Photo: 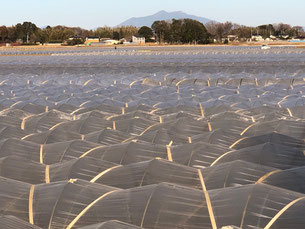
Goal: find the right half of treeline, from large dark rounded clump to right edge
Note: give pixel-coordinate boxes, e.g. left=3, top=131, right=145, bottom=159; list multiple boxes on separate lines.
left=145, top=19, right=305, bottom=44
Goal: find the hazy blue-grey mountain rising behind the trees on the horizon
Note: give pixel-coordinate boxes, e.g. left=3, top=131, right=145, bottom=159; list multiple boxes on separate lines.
left=118, top=10, right=212, bottom=27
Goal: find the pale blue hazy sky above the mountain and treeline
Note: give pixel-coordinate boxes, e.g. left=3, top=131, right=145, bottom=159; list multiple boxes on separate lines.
left=0, top=0, right=305, bottom=29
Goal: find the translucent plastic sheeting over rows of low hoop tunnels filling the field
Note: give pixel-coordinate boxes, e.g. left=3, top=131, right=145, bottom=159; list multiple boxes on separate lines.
left=0, top=48, right=305, bottom=229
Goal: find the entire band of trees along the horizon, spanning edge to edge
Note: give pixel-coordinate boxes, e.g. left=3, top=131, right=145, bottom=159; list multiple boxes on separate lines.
left=0, top=19, right=305, bottom=44
